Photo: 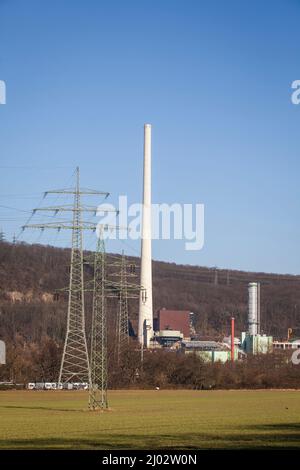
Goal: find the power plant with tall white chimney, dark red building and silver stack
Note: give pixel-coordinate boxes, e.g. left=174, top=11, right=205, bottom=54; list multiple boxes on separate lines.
left=138, top=124, right=278, bottom=362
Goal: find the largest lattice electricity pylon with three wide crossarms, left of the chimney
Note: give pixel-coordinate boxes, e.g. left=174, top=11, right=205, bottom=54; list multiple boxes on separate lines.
left=23, top=167, right=109, bottom=383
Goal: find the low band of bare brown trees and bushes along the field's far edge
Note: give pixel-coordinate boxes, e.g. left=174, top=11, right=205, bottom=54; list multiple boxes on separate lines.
left=0, top=335, right=300, bottom=390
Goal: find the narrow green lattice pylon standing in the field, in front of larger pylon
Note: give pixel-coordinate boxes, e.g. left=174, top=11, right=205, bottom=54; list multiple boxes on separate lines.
left=89, top=237, right=108, bottom=410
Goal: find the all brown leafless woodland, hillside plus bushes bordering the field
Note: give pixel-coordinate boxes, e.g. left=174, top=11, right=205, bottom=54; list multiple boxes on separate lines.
left=0, top=242, right=300, bottom=388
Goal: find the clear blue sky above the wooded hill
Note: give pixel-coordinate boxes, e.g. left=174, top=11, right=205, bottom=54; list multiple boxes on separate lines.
left=0, top=0, right=300, bottom=274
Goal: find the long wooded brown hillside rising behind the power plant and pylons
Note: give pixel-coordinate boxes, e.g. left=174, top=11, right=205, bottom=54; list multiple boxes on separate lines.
left=0, top=242, right=300, bottom=343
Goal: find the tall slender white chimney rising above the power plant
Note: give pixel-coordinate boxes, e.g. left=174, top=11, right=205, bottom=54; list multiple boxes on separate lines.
left=138, top=124, right=153, bottom=348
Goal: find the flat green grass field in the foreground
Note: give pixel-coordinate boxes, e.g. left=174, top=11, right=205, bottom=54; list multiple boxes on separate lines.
left=0, top=390, right=300, bottom=450
